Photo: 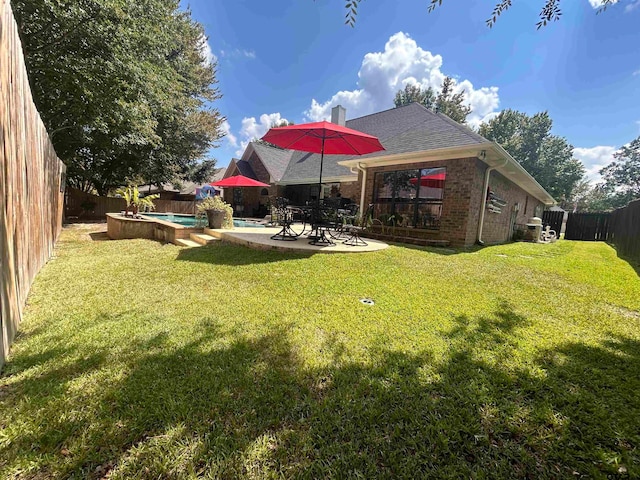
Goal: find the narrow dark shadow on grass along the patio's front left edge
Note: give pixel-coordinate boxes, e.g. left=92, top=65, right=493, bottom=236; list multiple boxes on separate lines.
left=176, top=243, right=312, bottom=265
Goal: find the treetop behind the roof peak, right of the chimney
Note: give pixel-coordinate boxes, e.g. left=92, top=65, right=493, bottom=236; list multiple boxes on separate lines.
left=393, top=77, right=471, bottom=123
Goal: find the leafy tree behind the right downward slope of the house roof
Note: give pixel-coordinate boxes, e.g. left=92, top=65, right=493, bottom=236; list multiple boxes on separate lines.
left=479, top=110, right=585, bottom=203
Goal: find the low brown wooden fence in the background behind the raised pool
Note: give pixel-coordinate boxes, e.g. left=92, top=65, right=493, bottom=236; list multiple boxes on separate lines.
left=65, top=188, right=196, bottom=220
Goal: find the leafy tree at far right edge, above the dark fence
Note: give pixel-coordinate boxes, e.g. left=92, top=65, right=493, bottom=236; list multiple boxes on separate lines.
left=598, top=136, right=640, bottom=208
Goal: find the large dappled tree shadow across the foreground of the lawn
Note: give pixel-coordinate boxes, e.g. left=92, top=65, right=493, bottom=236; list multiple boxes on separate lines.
left=0, top=303, right=640, bottom=478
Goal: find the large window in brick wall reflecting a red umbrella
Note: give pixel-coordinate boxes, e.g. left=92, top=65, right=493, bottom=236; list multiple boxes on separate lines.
left=373, top=168, right=447, bottom=230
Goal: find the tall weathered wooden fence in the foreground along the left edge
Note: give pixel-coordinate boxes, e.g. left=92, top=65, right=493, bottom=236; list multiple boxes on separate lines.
left=0, top=0, right=65, bottom=367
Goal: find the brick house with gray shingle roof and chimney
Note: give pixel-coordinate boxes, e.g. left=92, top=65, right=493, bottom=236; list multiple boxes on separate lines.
left=225, top=103, right=555, bottom=246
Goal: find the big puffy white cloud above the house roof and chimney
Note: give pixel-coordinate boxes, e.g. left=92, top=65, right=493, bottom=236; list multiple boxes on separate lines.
left=304, top=32, right=499, bottom=126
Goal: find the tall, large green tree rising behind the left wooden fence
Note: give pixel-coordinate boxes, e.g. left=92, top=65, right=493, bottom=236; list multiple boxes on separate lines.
left=12, top=0, right=224, bottom=194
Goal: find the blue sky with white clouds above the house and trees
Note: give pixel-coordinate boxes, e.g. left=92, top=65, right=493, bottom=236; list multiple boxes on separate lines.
left=183, top=0, right=640, bottom=179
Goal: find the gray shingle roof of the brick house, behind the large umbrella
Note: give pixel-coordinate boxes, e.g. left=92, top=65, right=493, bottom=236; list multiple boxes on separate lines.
left=276, top=103, right=488, bottom=183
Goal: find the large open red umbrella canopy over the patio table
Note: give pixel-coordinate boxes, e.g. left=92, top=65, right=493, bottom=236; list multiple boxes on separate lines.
left=262, top=121, right=384, bottom=155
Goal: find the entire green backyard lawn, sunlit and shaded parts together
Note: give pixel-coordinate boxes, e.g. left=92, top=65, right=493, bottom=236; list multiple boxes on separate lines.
left=0, top=227, right=640, bottom=479
